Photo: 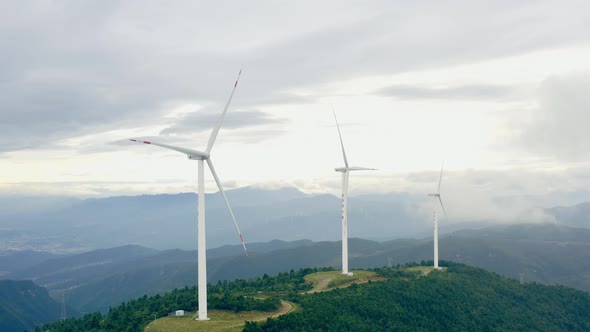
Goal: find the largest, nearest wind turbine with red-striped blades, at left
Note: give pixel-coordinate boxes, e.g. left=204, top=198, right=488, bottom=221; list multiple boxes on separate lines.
left=131, top=70, right=248, bottom=320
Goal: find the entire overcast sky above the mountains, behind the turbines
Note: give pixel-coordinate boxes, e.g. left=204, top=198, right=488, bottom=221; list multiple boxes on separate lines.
left=0, top=0, right=590, bottom=222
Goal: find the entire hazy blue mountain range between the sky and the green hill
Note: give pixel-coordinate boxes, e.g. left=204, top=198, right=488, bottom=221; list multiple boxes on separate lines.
left=0, top=187, right=590, bottom=322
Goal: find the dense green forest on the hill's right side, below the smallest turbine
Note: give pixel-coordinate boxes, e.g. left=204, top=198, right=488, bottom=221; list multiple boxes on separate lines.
left=244, top=263, right=590, bottom=332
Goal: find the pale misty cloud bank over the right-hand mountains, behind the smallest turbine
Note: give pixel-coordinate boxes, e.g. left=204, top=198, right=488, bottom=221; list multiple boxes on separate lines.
left=342, top=167, right=590, bottom=223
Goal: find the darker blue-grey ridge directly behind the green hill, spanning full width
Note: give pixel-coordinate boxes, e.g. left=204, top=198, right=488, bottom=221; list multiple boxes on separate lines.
left=9, top=224, right=590, bottom=312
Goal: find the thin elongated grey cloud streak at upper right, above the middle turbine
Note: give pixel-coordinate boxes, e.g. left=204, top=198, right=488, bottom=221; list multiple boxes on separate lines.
left=375, top=84, right=515, bottom=100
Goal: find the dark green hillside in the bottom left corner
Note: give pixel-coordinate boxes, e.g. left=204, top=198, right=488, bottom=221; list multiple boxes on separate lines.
left=0, top=280, right=61, bottom=332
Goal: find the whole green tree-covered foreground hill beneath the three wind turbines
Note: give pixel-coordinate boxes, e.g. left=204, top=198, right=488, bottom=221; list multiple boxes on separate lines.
left=38, top=262, right=590, bottom=332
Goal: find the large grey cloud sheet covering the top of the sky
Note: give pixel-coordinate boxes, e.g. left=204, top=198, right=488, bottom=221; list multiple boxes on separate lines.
left=0, top=1, right=590, bottom=153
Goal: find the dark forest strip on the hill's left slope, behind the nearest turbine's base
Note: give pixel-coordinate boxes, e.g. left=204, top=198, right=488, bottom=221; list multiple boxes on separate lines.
left=37, top=269, right=320, bottom=332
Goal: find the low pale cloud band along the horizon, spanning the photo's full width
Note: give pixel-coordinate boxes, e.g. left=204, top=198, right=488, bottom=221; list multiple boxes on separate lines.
left=6, top=166, right=590, bottom=223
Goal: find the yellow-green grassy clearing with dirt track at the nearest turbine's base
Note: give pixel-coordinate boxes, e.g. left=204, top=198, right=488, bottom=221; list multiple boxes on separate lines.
left=145, top=301, right=299, bottom=332
